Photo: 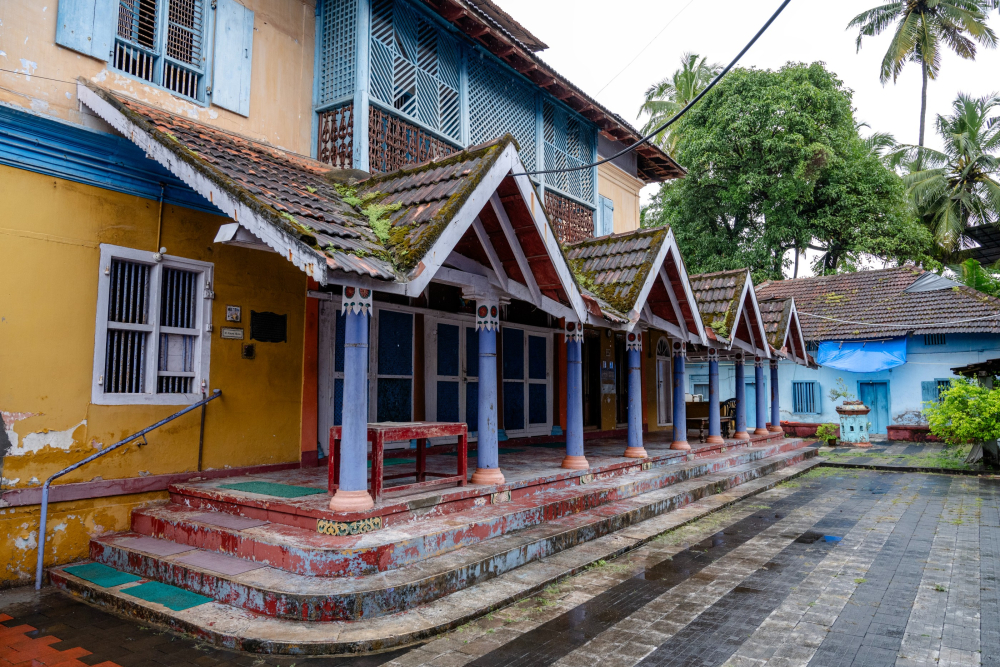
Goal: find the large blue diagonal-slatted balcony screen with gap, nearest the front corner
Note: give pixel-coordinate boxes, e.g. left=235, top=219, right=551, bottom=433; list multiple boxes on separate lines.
left=366, top=0, right=462, bottom=142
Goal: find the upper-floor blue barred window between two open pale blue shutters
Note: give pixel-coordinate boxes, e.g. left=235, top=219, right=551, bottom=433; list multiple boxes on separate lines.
left=112, top=0, right=206, bottom=100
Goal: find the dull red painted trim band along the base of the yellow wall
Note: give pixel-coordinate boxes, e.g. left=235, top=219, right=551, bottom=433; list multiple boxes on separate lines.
left=2, top=461, right=299, bottom=507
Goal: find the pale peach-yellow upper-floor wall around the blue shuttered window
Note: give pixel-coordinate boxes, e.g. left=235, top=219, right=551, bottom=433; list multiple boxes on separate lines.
left=0, top=0, right=316, bottom=155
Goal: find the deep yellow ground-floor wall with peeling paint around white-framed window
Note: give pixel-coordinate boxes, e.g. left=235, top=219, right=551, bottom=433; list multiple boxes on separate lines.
left=0, top=166, right=306, bottom=578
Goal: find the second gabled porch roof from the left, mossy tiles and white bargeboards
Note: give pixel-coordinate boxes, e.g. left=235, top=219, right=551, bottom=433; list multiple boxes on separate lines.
left=567, top=227, right=708, bottom=344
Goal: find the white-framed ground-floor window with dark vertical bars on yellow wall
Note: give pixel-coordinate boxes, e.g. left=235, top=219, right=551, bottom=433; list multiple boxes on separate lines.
left=92, top=245, right=212, bottom=405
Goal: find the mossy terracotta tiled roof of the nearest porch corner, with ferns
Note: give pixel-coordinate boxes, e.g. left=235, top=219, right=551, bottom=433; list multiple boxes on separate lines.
left=91, top=87, right=513, bottom=280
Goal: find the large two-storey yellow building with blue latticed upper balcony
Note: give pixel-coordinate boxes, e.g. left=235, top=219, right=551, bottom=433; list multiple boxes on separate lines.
left=0, top=0, right=703, bottom=584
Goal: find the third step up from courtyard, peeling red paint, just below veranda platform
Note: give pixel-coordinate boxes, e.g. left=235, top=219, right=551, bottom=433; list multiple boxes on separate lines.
left=127, top=439, right=806, bottom=577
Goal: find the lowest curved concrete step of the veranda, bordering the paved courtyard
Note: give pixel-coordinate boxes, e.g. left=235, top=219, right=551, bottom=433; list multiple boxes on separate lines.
left=50, top=450, right=820, bottom=655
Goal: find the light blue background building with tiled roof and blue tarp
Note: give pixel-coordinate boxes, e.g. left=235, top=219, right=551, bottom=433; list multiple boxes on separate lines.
left=757, top=267, right=1000, bottom=434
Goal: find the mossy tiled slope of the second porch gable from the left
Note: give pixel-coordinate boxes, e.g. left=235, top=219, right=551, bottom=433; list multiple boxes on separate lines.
left=566, top=227, right=669, bottom=315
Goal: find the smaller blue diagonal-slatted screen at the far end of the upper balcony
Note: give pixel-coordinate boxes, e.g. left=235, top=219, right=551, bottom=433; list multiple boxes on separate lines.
left=542, top=102, right=597, bottom=202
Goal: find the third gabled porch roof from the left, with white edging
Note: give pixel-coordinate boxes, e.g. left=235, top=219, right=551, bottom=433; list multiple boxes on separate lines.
left=691, top=269, right=771, bottom=359
